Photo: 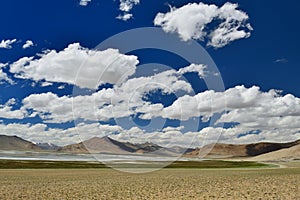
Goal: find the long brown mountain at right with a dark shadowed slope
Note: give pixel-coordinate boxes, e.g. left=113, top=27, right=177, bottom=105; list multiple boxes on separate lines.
left=186, top=140, right=300, bottom=158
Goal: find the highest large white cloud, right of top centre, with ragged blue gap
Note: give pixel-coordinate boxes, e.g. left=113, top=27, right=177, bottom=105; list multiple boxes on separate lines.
left=154, top=2, right=252, bottom=48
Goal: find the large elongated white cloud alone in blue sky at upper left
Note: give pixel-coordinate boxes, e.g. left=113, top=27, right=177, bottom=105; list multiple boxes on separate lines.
left=10, top=43, right=139, bottom=89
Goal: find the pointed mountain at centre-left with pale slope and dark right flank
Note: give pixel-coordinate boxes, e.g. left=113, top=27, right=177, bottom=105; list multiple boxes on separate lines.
left=58, top=137, right=162, bottom=154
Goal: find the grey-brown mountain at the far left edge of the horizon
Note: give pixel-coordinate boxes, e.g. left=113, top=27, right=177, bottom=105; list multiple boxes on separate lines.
left=0, top=135, right=42, bottom=151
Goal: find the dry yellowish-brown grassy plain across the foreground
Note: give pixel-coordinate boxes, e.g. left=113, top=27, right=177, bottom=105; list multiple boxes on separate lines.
left=0, top=168, right=300, bottom=199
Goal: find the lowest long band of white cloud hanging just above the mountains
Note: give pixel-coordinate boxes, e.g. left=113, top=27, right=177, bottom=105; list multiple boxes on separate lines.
left=0, top=119, right=300, bottom=147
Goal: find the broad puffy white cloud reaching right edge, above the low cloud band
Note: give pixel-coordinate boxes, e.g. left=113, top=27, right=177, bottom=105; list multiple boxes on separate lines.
left=162, top=86, right=300, bottom=136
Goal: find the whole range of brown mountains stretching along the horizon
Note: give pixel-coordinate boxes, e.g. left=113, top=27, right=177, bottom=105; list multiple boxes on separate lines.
left=0, top=135, right=300, bottom=161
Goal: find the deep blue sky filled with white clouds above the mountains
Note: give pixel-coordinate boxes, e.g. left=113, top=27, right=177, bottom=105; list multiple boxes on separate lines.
left=0, top=0, right=300, bottom=145
